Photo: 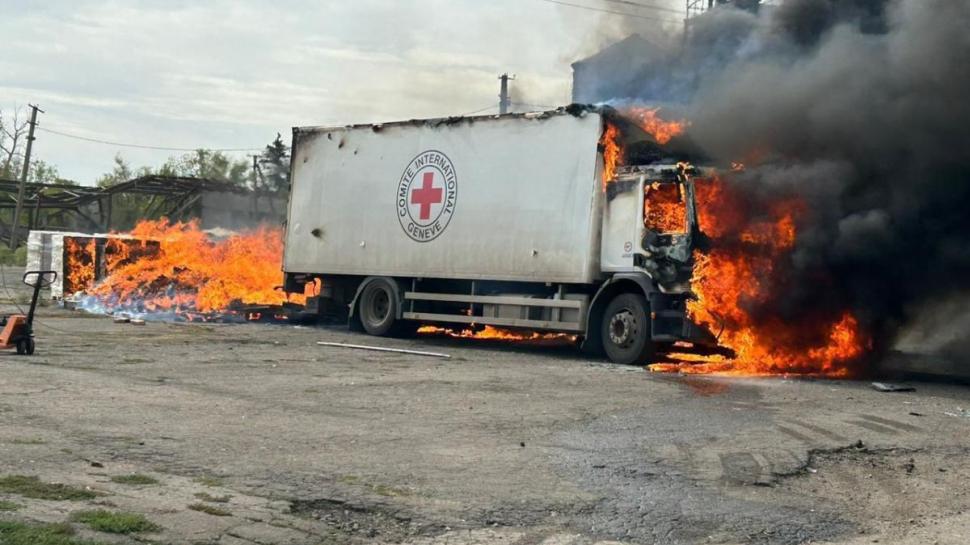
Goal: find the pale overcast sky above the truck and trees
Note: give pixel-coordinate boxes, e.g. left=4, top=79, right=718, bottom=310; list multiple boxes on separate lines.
left=0, top=0, right=683, bottom=184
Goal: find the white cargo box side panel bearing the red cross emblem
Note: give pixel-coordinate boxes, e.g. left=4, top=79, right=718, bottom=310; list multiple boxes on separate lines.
left=284, top=113, right=603, bottom=283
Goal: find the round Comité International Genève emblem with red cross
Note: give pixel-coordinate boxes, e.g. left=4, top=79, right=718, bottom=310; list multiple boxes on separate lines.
left=396, top=150, right=458, bottom=242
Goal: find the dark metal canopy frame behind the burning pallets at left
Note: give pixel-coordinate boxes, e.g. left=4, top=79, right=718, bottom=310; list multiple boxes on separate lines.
left=0, top=175, right=252, bottom=240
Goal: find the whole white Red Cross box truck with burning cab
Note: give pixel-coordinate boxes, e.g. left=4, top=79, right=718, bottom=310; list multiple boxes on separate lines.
left=284, top=105, right=716, bottom=364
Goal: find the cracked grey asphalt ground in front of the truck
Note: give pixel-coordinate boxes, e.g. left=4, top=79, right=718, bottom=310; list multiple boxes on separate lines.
left=0, top=269, right=970, bottom=545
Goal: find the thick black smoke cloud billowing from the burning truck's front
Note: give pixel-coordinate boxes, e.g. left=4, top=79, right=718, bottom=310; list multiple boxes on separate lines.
left=596, top=0, right=970, bottom=362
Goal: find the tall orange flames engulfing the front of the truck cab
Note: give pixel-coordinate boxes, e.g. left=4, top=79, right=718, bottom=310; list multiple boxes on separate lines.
left=651, top=174, right=868, bottom=377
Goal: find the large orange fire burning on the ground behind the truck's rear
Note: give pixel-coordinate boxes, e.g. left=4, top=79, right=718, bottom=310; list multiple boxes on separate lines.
left=75, top=219, right=304, bottom=315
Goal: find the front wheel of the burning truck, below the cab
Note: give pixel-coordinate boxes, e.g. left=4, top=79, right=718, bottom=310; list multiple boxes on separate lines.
left=601, top=293, right=654, bottom=365
